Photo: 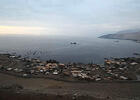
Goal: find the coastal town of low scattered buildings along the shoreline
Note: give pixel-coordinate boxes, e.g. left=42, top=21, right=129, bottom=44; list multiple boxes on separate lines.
left=0, top=54, right=140, bottom=82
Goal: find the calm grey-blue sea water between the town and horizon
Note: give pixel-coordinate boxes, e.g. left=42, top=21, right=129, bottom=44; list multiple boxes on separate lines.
left=0, top=36, right=140, bottom=63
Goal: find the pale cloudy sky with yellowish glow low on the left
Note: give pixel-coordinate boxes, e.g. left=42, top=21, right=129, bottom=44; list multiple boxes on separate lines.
left=0, top=0, right=140, bottom=36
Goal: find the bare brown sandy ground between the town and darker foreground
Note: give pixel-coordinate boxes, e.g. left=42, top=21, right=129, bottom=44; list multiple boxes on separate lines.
left=0, top=73, right=140, bottom=100
